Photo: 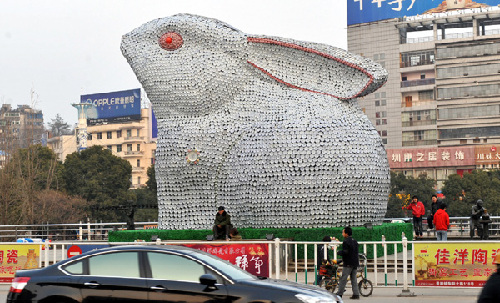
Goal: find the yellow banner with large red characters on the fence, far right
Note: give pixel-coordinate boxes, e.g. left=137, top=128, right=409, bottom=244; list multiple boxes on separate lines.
left=414, top=242, right=500, bottom=287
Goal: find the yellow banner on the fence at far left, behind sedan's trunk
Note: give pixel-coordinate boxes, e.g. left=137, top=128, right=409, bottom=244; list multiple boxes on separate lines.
left=0, top=244, right=40, bottom=283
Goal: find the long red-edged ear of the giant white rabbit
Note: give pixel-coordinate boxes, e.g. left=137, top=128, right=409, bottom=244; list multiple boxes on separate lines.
left=247, top=36, right=387, bottom=99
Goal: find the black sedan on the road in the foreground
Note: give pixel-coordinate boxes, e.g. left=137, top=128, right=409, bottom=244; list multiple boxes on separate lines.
left=7, top=245, right=342, bottom=303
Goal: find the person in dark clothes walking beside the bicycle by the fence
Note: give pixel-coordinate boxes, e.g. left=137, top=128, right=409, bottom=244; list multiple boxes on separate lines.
left=337, top=227, right=359, bottom=300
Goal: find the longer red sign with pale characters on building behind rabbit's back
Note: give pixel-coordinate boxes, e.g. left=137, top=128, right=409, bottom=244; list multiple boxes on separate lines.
left=387, top=146, right=476, bottom=169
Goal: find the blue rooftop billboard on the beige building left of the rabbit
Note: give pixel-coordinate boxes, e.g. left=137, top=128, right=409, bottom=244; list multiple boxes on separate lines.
left=80, top=88, right=141, bottom=125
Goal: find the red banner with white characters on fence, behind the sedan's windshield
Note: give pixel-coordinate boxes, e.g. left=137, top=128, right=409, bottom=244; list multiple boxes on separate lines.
left=182, top=244, right=269, bottom=277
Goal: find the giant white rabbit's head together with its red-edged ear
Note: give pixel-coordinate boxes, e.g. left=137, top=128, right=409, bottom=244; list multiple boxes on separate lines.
left=121, top=14, right=387, bottom=118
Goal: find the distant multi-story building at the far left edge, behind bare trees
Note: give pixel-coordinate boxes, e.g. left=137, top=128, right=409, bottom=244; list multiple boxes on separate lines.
left=0, top=104, right=45, bottom=153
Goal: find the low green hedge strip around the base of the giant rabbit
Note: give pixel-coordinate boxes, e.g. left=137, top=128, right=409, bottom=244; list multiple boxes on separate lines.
left=108, top=223, right=413, bottom=258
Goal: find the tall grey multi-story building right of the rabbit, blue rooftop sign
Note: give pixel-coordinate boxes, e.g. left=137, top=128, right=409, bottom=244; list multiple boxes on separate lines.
left=347, top=0, right=500, bottom=188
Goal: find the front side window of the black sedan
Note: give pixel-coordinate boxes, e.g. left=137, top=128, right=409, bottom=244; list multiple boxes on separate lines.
left=148, top=252, right=205, bottom=282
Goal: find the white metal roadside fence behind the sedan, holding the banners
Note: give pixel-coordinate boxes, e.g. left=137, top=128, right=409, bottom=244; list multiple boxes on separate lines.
left=6, top=236, right=492, bottom=291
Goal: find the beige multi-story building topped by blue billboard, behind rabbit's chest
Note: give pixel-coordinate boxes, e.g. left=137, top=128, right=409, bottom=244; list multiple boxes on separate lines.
left=74, top=89, right=156, bottom=188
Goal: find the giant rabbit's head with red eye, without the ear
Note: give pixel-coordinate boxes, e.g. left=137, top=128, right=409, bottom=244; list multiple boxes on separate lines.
left=121, top=14, right=247, bottom=117
